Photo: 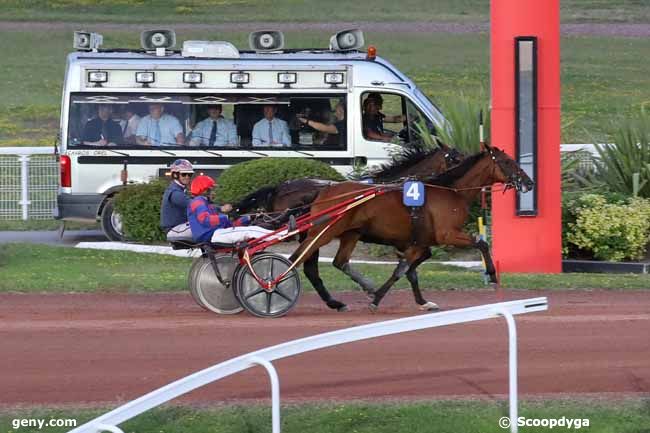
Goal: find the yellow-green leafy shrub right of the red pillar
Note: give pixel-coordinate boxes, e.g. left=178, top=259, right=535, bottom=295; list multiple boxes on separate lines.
left=565, top=194, right=650, bottom=261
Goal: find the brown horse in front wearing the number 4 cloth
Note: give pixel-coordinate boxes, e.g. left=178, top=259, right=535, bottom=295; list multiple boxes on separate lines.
left=291, top=146, right=533, bottom=310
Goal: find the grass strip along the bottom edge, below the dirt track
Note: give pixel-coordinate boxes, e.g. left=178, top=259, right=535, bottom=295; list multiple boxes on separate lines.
left=0, top=400, right=650, bottom=433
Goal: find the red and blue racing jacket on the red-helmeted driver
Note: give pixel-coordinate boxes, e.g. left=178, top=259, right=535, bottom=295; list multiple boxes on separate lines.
left=187, top=196, right=250, bottom=242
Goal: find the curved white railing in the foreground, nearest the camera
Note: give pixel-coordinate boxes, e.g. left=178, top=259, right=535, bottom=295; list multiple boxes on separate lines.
left=70, top=297, right=548, bottom=433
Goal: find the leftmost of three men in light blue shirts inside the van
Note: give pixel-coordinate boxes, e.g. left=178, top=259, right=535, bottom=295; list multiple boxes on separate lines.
left=136, top=104, right=185, bottom=146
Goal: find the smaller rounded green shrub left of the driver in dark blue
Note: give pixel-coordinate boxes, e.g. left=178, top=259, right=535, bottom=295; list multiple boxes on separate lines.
left=114, top=179, right=169, bottom=242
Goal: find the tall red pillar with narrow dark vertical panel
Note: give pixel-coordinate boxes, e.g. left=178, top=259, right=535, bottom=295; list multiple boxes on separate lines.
left=490, top=0, right=562, bottom=273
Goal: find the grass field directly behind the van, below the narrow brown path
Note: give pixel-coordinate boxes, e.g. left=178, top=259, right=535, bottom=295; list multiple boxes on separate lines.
left=0, top=29, right=650, bottom=146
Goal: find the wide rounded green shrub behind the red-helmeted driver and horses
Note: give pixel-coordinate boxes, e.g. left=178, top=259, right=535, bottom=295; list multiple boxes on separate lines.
left=216, top=158, right=344, bottom=203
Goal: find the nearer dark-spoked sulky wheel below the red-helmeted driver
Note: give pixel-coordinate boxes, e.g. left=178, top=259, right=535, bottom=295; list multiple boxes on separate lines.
left=234, top=253, right=300, bottom=317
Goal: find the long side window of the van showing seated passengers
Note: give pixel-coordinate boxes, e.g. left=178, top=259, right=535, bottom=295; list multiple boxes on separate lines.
left=67, top=93, right=347, bottom=150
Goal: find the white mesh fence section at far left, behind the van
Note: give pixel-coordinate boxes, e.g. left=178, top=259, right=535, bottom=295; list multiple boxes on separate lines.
left=0, top=147, right=59, bottom=220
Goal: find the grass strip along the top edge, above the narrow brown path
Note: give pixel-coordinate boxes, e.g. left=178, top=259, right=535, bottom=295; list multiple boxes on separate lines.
left=0, top=0, right=650, bottom=23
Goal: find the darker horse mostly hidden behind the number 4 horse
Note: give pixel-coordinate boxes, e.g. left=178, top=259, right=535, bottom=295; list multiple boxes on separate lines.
left=230, top=143, right=465, bottom=311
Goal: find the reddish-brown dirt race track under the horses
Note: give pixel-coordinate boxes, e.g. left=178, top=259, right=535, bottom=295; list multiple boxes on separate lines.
left=0, top=291, right=650, bottom=407
